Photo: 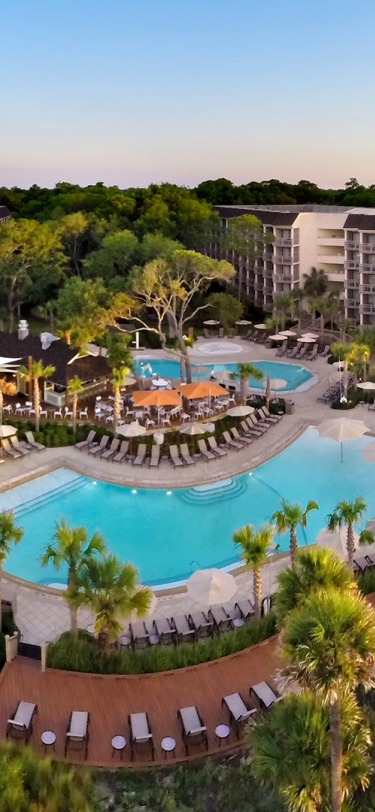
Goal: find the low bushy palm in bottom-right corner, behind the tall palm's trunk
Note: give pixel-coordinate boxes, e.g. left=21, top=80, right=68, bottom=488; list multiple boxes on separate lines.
left=249, top=691, right=371, bottom=812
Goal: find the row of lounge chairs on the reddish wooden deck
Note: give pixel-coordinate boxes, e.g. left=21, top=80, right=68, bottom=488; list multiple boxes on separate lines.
left=6, top=682, right=281, bottom=761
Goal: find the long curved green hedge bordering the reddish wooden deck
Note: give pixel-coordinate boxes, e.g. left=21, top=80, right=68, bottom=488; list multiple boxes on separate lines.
left=47, top=612, right=276, bottom=674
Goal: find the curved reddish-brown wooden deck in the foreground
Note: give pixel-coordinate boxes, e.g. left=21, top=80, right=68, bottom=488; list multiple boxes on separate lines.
left=0, top=637, right=280, bottom=767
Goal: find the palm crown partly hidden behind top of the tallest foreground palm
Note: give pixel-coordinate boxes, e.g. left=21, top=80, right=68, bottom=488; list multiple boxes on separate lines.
left=275, top=546, right=358, bottom=624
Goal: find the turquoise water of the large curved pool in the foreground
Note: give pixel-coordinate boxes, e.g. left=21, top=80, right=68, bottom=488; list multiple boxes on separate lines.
left=0, top=428, right=375, bottom=585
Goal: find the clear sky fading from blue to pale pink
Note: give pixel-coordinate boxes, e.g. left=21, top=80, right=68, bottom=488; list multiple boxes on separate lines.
left=0, top=0, right=375, bottom=188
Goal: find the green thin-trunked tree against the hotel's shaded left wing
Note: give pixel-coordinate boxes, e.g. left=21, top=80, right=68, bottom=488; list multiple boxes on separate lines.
left=222, top=214, right=275, bottom=299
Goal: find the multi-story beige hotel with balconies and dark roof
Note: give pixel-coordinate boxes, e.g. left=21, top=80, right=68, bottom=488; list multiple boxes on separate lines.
left=208, top=205, right=375, bottom=325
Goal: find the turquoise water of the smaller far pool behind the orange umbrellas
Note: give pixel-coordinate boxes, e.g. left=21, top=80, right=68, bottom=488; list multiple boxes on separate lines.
left=135, top=357, right=313, bottom=392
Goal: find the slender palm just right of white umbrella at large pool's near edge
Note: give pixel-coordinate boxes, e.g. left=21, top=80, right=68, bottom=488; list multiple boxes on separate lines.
left=233, top=524, right=274, bottom=618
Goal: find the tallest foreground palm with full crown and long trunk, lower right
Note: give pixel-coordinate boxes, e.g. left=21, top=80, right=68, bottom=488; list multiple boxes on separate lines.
left=281, top=588, right=375, bottom=812
